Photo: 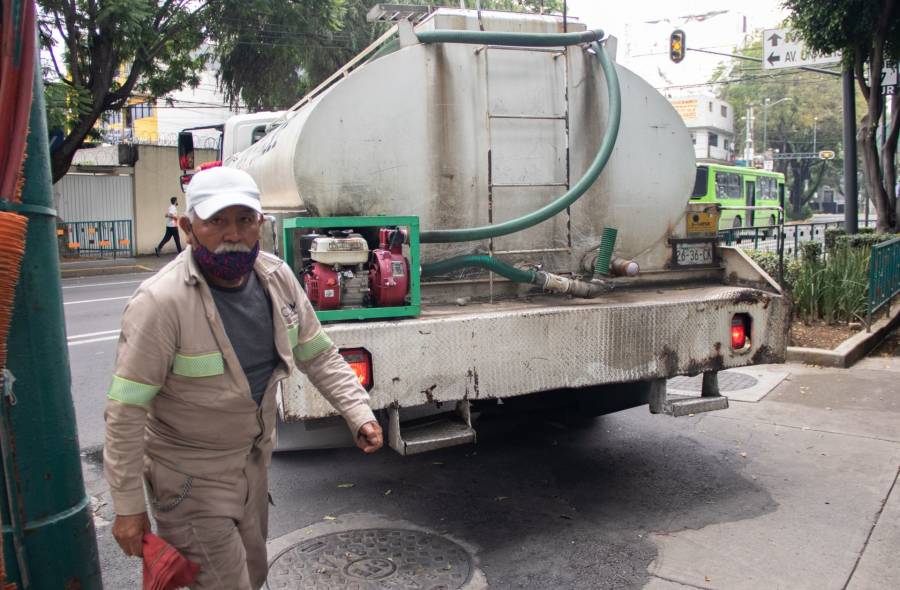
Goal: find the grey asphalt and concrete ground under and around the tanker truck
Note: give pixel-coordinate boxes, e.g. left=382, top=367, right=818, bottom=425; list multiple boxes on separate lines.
left=63, top=275, right=900, bottom=590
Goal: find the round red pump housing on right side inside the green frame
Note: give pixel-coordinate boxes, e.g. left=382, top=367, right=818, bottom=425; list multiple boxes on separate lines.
left=369, top=227, right=409, bottom=307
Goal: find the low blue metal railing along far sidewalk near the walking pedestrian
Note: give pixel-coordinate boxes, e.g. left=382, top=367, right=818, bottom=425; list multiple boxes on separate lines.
left=56, top=219, right=134, bottom=258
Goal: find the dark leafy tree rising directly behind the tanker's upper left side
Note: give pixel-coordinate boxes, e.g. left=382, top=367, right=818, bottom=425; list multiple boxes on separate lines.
left=210, top=0, right=563, bottom=110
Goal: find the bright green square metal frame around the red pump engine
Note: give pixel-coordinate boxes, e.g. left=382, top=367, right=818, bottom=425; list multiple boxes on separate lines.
left=281, top=215, right=422, bottom=322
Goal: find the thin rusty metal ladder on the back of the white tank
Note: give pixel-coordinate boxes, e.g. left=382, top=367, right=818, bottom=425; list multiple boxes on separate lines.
left=476, top=45, right=572, bottom=303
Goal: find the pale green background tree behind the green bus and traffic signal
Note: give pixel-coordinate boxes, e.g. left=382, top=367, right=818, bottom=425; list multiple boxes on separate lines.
left=712, top=39, right=841, bottom=219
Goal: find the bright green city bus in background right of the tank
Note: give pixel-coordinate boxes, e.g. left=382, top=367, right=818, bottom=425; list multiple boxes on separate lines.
left=691, top=163, right=784, bottom=229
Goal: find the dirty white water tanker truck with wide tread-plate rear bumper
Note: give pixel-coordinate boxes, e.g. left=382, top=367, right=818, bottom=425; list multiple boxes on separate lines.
left=176, top=6, right=789, bottom=454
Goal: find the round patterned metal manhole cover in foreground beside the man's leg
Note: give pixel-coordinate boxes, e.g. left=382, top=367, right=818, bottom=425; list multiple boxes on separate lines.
left=266, top=529, right=472, bottom=590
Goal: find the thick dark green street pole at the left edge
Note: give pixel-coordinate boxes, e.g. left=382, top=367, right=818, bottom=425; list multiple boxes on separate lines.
left=0, top=45, right=102, bottom=590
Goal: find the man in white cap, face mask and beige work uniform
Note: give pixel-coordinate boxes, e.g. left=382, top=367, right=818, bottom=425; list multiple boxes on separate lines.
left=103, top=167, right=382, bottom=590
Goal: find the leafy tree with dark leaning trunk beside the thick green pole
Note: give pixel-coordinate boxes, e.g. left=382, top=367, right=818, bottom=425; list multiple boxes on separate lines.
left=37, top=0, right=209, bottom=182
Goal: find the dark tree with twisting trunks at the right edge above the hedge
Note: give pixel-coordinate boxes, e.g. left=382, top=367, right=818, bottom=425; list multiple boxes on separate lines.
left=784, top=0, right=900, bottom=232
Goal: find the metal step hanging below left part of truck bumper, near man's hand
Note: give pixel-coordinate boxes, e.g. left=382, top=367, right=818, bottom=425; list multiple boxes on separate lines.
left=388, top=401, right=475, bottom=455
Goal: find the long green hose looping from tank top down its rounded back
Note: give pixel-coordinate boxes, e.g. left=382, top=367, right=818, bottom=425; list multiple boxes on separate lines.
left=418, top=31, right=622, bottom=244
